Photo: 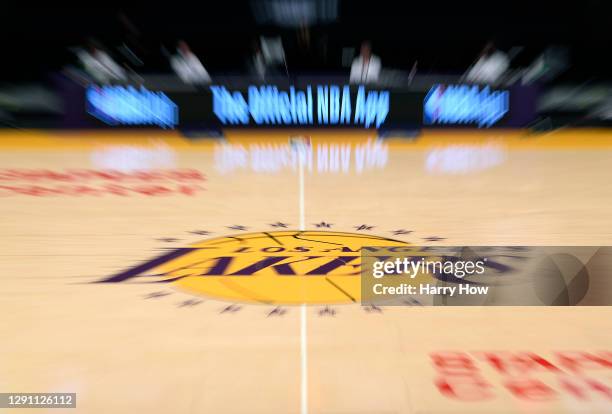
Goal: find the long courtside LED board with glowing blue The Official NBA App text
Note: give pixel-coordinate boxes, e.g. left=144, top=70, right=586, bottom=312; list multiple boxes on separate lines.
left=81, top=83, right=537, bottom=130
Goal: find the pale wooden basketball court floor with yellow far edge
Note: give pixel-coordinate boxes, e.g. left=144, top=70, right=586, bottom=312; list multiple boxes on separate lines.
left=0, top=130, right=612, bottom=414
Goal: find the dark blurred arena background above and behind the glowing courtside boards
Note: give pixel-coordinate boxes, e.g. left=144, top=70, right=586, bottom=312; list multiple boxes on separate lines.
left=0, top=0, right=612, bottom=129
